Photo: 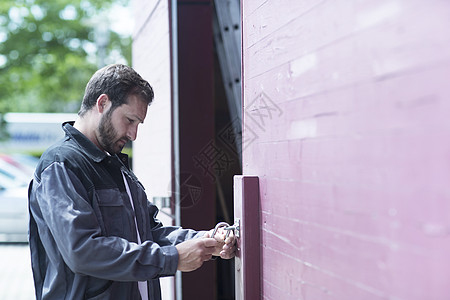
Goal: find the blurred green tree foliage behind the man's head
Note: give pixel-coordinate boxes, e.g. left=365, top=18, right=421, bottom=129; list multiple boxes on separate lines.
left=0, top=0, right=131, bottom=114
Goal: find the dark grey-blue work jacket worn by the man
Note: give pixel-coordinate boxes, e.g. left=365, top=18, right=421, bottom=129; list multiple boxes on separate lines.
left=29, top=123, right=203, bottom=300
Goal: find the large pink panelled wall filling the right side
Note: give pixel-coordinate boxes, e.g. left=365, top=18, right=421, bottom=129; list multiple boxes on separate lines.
left=242, top=0, right=450, bottom=300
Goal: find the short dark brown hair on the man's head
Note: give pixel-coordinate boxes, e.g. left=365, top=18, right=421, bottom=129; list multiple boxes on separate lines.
left=78, top=64, right=154, bottom=116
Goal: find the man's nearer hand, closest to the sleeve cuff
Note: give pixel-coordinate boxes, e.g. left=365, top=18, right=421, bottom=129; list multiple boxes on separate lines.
left=176, top=238, right=218, bottom=272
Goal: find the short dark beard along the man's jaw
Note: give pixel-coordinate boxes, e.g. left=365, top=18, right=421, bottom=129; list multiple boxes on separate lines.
left=98, top=109, right=129, bottom=154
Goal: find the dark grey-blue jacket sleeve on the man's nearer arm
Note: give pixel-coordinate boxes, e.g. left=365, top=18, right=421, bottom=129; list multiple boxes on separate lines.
left=30, top=163, right=178, bottom=281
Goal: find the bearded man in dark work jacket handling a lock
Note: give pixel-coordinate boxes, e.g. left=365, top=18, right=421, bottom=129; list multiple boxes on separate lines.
left=29, top=65, right=235, bottom=300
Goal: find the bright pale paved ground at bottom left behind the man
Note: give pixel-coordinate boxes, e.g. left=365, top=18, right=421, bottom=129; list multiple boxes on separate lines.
left=0, top=244, right=35, bottom=300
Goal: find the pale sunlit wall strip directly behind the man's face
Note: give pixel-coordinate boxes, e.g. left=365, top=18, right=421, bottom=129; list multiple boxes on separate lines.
left=133, top=0, right=174, bottom=300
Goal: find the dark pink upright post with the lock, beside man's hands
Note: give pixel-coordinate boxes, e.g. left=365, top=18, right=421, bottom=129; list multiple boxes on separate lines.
left=234, top=175, right=262, bottom=300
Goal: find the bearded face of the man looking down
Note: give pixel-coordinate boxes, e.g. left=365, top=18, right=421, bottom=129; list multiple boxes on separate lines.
left=97, top=95, right=148, bottom=154
